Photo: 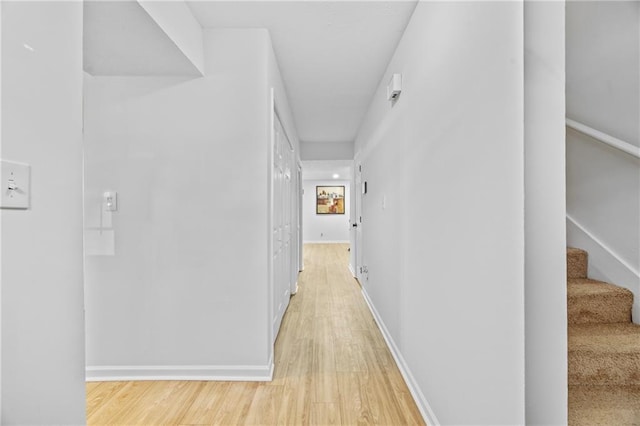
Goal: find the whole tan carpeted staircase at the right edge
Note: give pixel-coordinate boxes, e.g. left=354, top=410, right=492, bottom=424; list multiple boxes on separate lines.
left=567, top=248, right=640, bottom=425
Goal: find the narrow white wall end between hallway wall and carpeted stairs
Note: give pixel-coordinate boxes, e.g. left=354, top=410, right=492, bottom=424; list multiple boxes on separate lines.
left=524, top=1, right=567, bottom=425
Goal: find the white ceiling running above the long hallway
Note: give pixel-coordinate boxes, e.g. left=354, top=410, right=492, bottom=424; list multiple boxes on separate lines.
left=187, top=0, right=417, bottom=142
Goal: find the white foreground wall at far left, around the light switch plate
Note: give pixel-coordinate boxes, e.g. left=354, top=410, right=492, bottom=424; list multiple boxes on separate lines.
left=0, top=2, right=85, bottom=425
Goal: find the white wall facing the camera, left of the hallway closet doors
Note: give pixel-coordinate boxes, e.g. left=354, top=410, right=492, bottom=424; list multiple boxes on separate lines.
left=85, top=30, right=271, bottom=380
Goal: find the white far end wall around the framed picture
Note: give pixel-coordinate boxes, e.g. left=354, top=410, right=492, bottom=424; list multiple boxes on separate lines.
left=302, top=180, right=351, bottom=243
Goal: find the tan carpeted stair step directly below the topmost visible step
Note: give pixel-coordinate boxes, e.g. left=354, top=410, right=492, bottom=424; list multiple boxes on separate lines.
left=567, top=278, right=633, bottom=324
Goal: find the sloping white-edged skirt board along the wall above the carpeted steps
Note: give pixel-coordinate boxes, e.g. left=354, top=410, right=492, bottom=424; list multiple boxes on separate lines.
left=567, top=215, right=640, bottom=323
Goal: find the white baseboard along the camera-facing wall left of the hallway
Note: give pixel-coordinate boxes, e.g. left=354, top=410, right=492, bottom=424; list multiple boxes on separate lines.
left=86, top=362, right=274, bottom=382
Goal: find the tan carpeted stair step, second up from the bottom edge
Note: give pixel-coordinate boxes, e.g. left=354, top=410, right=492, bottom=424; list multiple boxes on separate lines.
left=568, top=323, right=640, bottom=386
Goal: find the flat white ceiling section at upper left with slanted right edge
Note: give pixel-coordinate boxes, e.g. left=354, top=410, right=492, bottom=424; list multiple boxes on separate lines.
left=83, top=0, right=201, bottom=76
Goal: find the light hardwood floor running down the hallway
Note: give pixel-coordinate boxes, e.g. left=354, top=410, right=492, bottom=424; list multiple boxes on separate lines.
left=87, top=244, right=424, bottom=425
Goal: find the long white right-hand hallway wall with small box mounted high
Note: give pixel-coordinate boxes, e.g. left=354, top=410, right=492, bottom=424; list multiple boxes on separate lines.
left=355, top=2, right=525, bottom=425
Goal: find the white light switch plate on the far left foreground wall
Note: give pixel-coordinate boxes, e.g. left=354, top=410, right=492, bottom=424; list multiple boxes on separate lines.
left=0, top=160, right=31, bottom=209
